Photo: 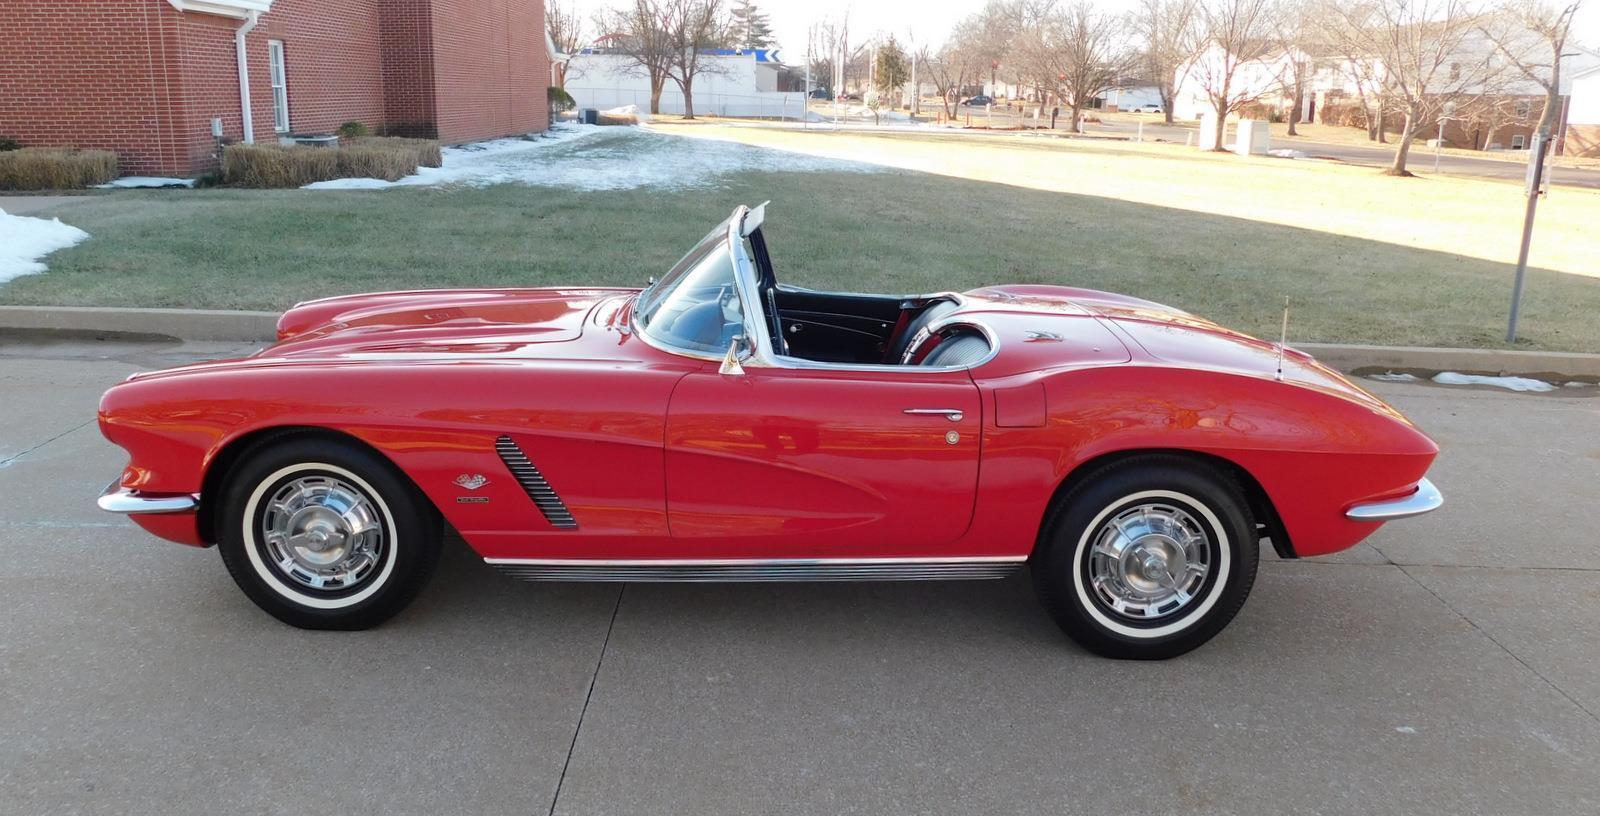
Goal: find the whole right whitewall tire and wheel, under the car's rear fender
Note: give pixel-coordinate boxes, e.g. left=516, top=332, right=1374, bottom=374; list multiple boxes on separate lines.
left=1032, top=454, right=1258, bottom=659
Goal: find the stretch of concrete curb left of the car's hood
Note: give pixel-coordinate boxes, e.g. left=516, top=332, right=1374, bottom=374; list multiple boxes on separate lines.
left=0, top=306, right=278, bottom=342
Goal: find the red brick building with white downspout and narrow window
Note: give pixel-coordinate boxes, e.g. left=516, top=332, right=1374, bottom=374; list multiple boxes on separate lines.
left=0, top=0, right=550, bottom=174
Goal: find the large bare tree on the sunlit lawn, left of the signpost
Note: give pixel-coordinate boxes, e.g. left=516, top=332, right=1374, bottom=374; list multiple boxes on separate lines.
left=1330, top=0, right=1499, bottom=176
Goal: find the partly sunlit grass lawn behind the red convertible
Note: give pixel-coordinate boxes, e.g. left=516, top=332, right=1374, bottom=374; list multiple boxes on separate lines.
left=0, top=126, right=1600, bottom=352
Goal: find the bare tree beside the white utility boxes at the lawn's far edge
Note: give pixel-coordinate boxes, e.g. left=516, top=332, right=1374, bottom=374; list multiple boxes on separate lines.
left=1189, top=0, right=1280, bottom=150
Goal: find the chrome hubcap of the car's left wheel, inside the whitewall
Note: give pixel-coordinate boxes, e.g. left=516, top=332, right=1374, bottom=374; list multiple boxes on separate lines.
left=261, top=475, right=384, bottom=590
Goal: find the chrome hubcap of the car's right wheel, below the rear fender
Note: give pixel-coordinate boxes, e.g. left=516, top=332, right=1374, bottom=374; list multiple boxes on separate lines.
left=1088, top=502, right=1211, bottom=621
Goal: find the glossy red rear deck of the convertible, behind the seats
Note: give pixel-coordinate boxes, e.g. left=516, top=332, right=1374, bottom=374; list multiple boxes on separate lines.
left=965, top=286, right=1405, bottom=421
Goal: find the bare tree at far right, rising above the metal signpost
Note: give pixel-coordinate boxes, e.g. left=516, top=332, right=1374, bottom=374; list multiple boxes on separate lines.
left=1478, top=0, right=1582, bottom=139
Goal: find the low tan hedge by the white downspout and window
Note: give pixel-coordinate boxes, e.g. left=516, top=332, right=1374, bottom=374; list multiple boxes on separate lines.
left=222, top=136, right=443, bottom=187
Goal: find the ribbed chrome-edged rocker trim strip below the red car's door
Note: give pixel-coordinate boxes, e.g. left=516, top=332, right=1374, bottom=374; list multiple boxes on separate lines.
left=483, top=555, right=1027, bottom=582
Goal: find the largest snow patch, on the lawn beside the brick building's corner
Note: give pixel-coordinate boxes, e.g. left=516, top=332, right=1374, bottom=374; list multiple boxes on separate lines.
left=306, top=123, right=882, bottom=190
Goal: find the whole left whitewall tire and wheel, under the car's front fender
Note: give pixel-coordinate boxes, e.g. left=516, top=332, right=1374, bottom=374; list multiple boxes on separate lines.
left=218, top=435, right=440, bottom=629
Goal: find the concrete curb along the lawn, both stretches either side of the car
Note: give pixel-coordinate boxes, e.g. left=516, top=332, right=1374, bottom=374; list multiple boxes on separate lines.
left=0, top=306, right=1600, bottom=379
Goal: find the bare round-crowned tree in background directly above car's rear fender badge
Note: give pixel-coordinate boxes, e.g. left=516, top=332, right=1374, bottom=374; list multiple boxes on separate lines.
left=1016, top=0, right=1138, bottom=130
